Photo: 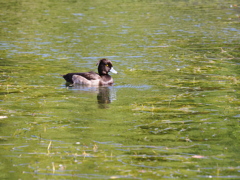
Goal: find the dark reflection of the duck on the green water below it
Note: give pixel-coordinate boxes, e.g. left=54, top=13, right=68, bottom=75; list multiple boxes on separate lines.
left=67, top=85, right=116, bottom=109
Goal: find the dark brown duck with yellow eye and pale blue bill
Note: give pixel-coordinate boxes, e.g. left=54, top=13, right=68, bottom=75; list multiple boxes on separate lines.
left=62, top=58, right=117, bottom=86
